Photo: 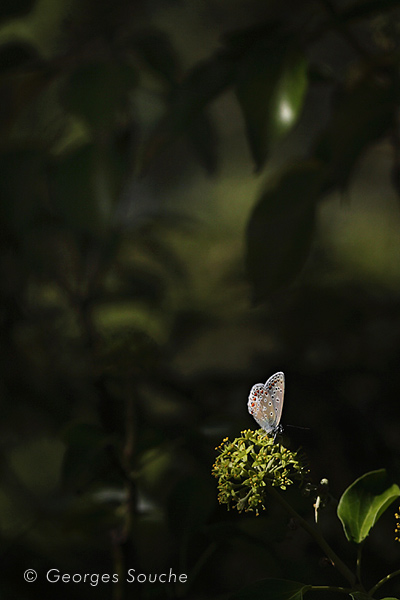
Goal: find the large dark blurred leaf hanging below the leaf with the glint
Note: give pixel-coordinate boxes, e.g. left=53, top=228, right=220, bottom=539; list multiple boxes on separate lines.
left=246, top=161, right=323, bottom=301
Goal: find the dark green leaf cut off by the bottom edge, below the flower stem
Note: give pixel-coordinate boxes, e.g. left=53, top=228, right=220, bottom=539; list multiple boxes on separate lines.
left=229, top=579, right=311, bottom=600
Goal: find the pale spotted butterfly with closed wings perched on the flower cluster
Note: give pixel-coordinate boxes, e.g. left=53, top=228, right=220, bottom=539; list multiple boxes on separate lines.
left=247, top=371, right=285, bottom=440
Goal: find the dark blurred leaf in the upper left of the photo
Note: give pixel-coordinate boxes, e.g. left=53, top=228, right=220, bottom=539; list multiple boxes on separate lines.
left=61, top=62, right=137, bottom=131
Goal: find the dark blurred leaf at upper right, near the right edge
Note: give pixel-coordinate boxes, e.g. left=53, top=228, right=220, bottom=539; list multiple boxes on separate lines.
left=315, top=77, right=396, bottom=189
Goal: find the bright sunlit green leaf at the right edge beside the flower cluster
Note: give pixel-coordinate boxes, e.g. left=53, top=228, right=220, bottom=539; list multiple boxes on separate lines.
left=337, top=469, right=400, bottom=544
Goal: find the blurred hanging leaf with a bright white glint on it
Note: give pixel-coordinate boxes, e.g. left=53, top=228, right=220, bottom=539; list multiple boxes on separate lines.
left=236, top=39, right=307, bottom=170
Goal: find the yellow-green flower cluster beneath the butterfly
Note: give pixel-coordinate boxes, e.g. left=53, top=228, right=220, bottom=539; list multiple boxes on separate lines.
left=212, top=429, right=309, bottom=515
